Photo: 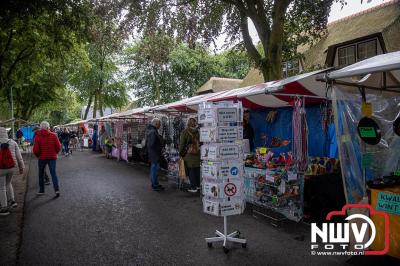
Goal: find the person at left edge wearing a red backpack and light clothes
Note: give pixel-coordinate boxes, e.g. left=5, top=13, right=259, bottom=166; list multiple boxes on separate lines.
left=0, top=127, right=25, bottom=216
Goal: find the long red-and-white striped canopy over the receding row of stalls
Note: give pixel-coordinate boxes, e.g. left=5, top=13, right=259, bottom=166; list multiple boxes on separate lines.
left=90, top=69, right=326, bottom=121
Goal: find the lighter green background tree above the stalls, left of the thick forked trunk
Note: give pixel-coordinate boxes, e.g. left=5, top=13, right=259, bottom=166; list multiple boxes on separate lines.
left=125, top=32, right=250, bottom=106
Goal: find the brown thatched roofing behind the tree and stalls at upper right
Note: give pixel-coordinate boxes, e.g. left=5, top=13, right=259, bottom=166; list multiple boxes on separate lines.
left=240, top=0, right=400, bottom=87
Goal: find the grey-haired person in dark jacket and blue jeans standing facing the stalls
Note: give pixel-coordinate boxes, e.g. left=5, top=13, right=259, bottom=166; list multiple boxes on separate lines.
left=145, top=118, right=164, bottom=191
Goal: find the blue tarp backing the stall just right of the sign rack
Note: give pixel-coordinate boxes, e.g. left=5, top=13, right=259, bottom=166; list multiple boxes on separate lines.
left=250, top=105, right=338, bottom=158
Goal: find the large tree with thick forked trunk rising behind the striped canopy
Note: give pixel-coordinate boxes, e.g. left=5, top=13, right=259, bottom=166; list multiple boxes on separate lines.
left=127, top=0, right=345, bottom=81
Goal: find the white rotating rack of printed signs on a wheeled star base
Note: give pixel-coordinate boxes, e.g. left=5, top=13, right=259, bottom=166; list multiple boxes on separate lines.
left=198, top=102, right=247, bottom=253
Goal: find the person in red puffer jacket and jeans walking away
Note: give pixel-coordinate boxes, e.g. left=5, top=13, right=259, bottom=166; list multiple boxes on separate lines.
left=33, top=121, right=61, bottom=197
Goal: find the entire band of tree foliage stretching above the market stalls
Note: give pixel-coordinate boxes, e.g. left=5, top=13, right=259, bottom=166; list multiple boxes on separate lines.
left=0, top=0, right=362, bottom=123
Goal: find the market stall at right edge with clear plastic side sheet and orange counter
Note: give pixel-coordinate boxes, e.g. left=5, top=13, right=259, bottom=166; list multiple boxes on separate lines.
left=326, top=52, right=400, bottom=258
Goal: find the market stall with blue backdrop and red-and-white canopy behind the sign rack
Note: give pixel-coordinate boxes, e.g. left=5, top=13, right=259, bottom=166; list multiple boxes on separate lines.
left=150, top=70, right=344, bottom=221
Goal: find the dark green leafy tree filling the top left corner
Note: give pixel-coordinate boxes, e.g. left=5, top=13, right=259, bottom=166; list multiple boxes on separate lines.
left=0, top=0, right=87, bottom=120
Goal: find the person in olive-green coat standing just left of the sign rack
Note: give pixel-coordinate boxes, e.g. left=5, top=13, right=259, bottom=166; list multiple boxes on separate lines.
left=179, top=118, right=200, bottom=193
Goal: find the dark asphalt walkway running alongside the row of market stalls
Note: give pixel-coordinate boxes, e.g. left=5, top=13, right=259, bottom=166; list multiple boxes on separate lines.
left=19, top=152, right=346, bottom=266
